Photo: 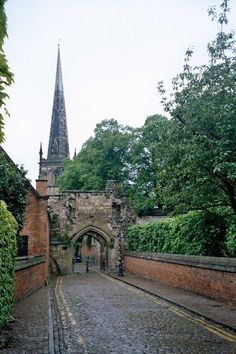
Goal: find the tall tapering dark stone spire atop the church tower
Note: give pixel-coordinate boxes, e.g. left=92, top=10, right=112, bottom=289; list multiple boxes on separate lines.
left=47, top=44, right=69, bottom=161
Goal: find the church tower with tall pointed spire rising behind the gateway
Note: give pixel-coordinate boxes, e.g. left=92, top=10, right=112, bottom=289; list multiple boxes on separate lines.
left=39, top=45, right=70, bottom=195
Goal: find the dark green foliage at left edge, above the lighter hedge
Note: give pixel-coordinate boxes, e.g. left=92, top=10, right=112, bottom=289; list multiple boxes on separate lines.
left=0, top=147, right=29, bottom=228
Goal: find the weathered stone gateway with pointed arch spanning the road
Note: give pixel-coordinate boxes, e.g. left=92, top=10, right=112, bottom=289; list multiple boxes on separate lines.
left=48, top=181, right=136, bottom=274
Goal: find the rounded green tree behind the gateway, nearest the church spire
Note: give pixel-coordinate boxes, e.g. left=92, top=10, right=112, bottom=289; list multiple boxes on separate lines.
left=58, top=119, right=131, bottom=190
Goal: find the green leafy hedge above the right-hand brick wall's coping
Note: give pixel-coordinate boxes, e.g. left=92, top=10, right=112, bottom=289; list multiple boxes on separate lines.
left=125, top=211, right=236, bottom=257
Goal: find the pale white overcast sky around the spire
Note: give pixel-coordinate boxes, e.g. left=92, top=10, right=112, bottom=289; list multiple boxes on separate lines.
left=3, top=0, right=236, bottom=184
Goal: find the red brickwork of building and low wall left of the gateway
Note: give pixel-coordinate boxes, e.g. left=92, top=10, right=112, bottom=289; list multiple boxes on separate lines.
left=14, top=181, right=49, bottom=300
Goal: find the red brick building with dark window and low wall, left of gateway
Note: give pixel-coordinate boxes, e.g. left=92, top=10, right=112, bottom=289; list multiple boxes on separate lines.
left=0, top=146, right=49, bottom=300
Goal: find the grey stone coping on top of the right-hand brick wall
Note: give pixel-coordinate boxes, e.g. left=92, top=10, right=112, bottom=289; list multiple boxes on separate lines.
left=125, top=251, right=236, bottom=273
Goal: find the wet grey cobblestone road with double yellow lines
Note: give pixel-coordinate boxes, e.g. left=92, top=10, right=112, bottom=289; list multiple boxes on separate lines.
left=52, top=265, right=236, bottom=354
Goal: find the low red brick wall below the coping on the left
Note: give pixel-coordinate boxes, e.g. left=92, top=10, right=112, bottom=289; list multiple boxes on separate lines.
left=14, top=263, right=46, bottom=306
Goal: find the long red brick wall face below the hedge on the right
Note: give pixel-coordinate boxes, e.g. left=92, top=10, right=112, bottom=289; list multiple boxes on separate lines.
left=125, top=256, right=236, bottom=304
